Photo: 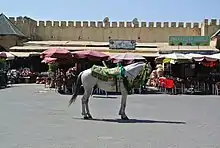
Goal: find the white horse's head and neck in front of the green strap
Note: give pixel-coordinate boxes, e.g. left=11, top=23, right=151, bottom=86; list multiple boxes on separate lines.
left=124, top=62, right=146, bottom=80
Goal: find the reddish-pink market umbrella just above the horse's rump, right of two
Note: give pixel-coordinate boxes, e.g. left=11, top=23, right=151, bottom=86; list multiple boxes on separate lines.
left=72, top=50, right=109, bottom=61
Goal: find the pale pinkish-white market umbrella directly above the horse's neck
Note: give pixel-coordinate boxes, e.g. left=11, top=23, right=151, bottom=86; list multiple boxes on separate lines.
left=109, top=53, right=146, bottom=64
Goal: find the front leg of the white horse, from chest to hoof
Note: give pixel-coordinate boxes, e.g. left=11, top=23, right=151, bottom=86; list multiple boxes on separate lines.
left=119, top=87, right=129, bottom=120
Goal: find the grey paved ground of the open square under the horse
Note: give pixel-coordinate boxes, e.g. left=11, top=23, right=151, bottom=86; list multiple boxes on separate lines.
left=0, top=85, right=220, bottom=148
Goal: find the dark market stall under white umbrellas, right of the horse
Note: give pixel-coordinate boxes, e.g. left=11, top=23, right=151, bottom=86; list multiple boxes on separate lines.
left=155, top=53, right=220, bottom=94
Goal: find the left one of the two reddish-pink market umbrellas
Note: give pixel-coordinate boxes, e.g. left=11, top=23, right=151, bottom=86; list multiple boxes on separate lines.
left=41, top=48, right=71, bottom=58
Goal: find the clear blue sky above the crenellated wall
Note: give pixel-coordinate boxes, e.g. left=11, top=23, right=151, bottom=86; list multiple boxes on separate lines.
left=0, top=0, right=220, bottom=22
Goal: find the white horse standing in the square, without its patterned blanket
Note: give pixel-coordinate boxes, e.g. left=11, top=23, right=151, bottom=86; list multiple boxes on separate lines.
left=69, top=63, right=146, bottom=120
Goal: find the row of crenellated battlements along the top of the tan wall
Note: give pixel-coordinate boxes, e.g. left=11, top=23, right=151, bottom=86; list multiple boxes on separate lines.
left=9, top=17, right=220, bottom=28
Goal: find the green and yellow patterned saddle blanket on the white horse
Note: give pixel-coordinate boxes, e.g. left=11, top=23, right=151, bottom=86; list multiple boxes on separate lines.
left=91, top=65, right=120, bottom=81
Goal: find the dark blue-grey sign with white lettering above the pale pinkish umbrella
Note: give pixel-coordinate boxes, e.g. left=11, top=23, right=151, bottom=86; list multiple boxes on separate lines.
left=109, top=40, right=136, bottom=50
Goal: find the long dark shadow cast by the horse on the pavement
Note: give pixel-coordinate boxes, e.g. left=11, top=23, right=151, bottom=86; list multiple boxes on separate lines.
left=73, top=118, right=186, bottom=124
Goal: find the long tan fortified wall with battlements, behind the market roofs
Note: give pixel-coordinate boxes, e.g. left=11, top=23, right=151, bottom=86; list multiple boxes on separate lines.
left=9, top=17, right=220, bottom=43
